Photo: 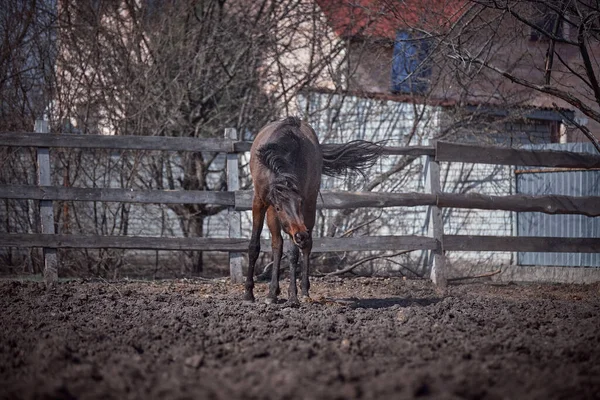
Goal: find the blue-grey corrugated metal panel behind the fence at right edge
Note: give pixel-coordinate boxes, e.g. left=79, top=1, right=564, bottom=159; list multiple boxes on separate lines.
left=517, top=143, right=600, bottom=267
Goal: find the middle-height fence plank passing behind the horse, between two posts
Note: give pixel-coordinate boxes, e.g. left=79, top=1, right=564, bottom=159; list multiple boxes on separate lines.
left=235, top=190, right=436, bottom=210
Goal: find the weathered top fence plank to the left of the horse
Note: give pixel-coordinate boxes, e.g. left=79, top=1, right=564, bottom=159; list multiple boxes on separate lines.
left=0, top=132, right=235, bottom=153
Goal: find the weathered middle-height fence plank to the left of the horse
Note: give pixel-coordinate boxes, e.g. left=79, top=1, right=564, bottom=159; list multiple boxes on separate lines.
left=0, top=185, right=235, bottom=206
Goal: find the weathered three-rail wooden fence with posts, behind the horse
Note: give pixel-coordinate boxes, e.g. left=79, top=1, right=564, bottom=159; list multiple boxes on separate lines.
left=0, top=121, right=600, bottom=286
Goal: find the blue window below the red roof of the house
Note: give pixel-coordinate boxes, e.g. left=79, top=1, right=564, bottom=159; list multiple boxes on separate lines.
left=392, top=31, right=431, bottom=94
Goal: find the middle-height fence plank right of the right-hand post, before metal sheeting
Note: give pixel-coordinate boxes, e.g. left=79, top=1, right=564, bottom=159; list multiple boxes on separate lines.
left=437, top=193, right=600, bottom=217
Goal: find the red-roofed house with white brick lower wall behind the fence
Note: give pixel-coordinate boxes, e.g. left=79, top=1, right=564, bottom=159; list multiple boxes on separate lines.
left=286, top=0, right=596, bottom=270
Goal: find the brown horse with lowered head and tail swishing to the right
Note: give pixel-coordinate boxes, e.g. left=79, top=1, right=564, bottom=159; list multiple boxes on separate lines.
left=245, top=117, right=382, bottom=304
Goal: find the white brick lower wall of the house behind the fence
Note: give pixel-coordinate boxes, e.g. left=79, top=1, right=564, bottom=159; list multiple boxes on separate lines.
left=299, top=92, right=568, bottom=264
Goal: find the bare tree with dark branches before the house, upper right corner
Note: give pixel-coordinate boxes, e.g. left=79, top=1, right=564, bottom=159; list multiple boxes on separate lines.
left=427, top=0, right=600, bottom=151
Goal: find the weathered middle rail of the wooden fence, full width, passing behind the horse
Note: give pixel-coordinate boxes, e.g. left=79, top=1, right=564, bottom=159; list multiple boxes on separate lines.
left=0, top=185, right=600, bottom=217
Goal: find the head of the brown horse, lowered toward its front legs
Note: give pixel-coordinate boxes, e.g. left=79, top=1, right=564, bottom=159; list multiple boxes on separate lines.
left=269, top=177, right=310, bottom=249
